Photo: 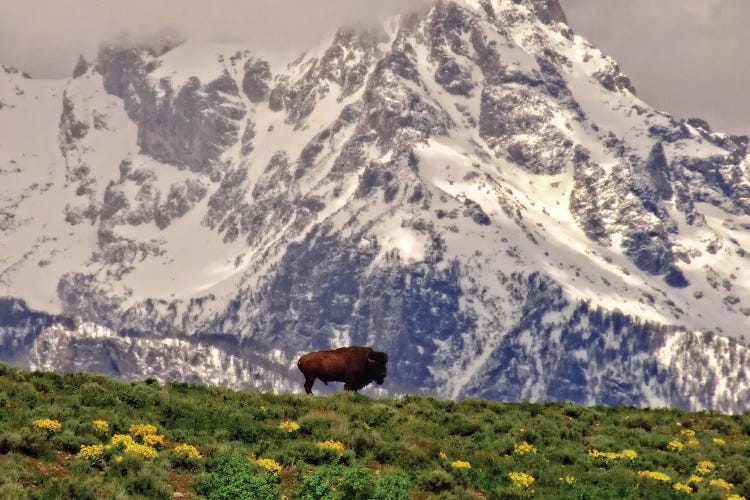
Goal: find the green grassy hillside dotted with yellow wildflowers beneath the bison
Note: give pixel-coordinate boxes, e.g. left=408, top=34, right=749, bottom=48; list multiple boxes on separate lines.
left=0, top=364, right=750, bottom=500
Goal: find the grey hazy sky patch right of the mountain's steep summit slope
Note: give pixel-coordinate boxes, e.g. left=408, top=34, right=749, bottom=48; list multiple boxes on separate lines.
left=560, top=0, right=750, bottom=135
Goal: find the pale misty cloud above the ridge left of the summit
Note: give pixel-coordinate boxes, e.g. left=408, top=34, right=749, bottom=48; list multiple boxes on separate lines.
left=0, top=0, right=426, bottom=78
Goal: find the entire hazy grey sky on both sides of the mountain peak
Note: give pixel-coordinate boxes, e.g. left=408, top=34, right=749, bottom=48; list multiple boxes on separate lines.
left=0, top=0, right=750, bottom=133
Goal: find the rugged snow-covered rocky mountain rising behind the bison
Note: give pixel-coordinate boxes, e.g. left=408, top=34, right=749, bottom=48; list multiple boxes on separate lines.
left=0, top=0, right=750, bottom=411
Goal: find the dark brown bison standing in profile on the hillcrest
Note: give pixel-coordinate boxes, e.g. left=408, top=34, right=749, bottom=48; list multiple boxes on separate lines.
left=297, top=346, right=388, bottom=394
